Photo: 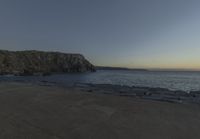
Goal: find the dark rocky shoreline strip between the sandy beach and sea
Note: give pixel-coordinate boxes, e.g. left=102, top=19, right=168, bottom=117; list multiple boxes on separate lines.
left=33, top=81, right=200, bottom=104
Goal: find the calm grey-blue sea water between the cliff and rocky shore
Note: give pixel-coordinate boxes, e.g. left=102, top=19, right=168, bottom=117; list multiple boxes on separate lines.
left=0, top=70, right=200, bottom=92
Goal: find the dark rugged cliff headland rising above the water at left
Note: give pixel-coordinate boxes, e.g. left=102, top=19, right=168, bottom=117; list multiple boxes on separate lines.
left=0, top=50, right=95, bottom=75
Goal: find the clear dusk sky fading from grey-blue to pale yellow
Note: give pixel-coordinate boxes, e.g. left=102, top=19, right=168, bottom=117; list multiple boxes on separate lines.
left=0, top=0, right=200, bottom=70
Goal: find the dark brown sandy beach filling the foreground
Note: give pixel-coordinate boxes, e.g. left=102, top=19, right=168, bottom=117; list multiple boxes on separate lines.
left=0, top=82, right=200, bottom=139
